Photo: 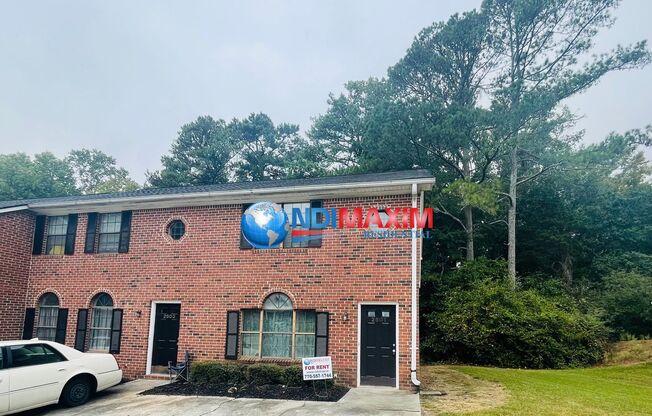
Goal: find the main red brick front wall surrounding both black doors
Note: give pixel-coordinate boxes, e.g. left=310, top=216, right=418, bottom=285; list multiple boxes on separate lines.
left=20, top=195, right=422, bottom=388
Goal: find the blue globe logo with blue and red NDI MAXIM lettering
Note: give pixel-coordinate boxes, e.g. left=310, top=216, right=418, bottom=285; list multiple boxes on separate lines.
left=240, top=201, right=434, bottom=249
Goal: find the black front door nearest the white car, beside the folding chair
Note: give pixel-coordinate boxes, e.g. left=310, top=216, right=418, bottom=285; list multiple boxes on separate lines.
left=152, top=303, right=181, bottom=372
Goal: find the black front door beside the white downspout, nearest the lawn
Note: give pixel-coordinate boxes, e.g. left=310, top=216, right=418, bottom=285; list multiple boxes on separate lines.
left=360, top=305, right=396, bottom=387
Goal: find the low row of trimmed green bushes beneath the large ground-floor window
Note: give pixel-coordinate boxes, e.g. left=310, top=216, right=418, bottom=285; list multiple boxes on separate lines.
left=190, top=361, right=303, bottom=386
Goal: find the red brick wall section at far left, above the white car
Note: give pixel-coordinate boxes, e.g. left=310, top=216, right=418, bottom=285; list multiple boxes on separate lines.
left=0, top=211, right=34, bottom=340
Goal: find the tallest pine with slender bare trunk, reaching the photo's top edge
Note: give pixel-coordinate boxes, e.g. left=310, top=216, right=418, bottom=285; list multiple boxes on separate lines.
left=482, top=0, right=650, bottom=287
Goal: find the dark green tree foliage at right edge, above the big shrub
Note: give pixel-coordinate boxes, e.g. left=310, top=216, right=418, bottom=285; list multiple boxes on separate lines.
left=518, top=130, right=652, bottom=289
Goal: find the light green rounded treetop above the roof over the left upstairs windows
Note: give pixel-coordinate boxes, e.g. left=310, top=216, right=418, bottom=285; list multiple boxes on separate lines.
left=65, top=149, right=140, bottom=194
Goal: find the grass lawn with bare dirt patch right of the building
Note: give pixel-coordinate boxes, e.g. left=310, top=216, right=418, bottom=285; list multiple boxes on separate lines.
left=421, top=342, right=652, bottom=416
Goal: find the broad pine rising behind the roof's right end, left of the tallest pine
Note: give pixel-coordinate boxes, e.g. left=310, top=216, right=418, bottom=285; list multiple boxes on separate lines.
left=310, top=11, right=499, bottom=260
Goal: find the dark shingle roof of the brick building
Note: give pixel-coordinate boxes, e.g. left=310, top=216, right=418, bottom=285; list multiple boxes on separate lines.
left=0, top=169, right=432, bottom=209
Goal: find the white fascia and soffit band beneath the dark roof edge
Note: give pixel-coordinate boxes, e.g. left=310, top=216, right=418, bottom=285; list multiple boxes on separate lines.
left=28, top=178, right=434, bottom=215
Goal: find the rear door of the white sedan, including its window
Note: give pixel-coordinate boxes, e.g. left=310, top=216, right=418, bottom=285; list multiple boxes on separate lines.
left=7, top=344, right=69, bottom=411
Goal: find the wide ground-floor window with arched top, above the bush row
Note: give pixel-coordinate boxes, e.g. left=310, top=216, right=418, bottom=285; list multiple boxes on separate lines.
left=240, top=293, right=315, bottom=358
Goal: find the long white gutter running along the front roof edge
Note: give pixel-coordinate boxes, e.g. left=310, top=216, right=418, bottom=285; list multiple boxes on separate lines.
left=28, top=178, right=434, bottom=209
